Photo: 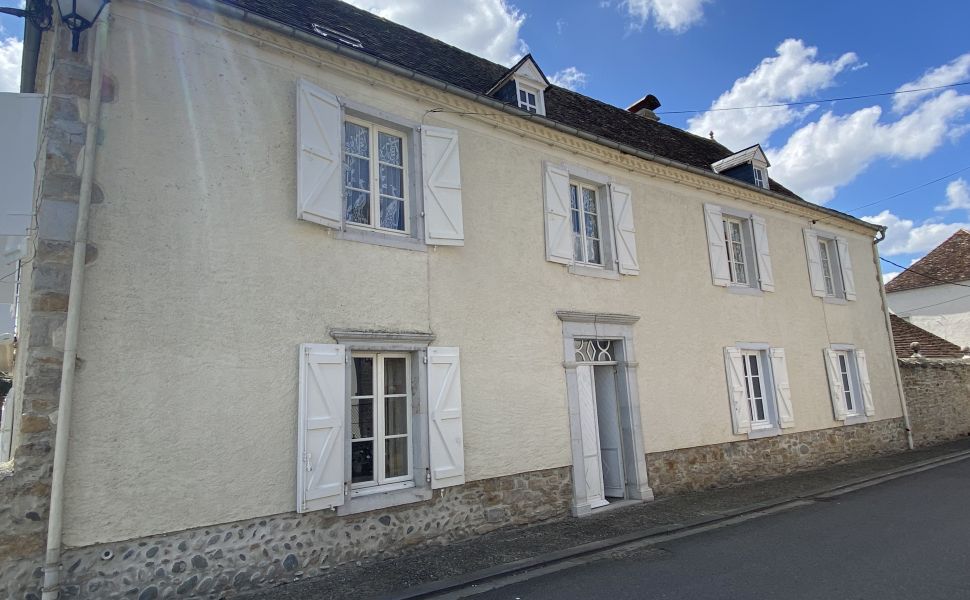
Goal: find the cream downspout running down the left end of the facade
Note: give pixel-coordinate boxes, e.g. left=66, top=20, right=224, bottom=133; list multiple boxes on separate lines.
left=43, top=3, right=111, bottom=600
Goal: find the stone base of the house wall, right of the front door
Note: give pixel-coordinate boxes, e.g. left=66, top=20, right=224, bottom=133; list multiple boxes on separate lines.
left=647, top=418, right=906, bottom=496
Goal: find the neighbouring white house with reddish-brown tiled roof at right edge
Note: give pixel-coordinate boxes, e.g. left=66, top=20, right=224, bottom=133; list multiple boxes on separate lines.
left=886, top=229, right=970, bottom=348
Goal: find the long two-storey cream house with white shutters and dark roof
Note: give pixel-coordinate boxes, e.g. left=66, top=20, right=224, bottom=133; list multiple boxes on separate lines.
left=0, top=0, right=907, bottom=598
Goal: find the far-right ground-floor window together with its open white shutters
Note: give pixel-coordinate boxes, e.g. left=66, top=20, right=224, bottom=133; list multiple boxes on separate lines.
left=824, top=344, right=875, bottom=423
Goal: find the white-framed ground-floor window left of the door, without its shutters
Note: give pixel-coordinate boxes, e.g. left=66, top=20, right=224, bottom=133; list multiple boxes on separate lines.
left=350, top=353, right=414, bottom=493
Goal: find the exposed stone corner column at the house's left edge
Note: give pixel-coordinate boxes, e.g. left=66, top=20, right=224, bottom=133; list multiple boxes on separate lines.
left=0, top=29, right=113, bottom=598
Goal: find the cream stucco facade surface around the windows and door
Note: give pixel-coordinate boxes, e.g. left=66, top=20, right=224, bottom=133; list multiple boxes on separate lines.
left=43, top=1, right=902, bottom=546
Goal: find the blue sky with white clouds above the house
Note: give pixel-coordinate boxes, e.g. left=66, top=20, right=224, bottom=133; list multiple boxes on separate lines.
left=0, top=0, right=970, bottom=272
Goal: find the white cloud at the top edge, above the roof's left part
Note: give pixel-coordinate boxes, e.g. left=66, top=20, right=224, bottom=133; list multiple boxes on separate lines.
left=347, top=0, right=528, bottom=66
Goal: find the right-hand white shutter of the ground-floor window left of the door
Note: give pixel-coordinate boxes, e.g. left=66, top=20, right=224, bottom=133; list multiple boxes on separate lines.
left=428, top=347, right=465, bottom=489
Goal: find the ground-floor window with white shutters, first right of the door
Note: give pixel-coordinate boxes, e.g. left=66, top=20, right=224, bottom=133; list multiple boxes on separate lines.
left=724, top=343, right=795, bottom=437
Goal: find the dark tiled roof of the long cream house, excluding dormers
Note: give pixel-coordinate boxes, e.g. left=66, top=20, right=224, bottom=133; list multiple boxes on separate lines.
left=217, top=0, right=798, bottom=198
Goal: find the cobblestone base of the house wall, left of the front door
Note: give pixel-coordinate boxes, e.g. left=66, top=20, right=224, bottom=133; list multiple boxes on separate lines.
left=3, top=467, right=572, bottom=600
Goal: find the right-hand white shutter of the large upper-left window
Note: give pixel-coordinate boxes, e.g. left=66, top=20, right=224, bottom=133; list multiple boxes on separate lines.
left=421, top=125, right=465, bottom=246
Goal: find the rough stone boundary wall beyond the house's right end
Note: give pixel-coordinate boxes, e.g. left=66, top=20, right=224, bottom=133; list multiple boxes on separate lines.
left=899, top=358, right=970, bottom=446
